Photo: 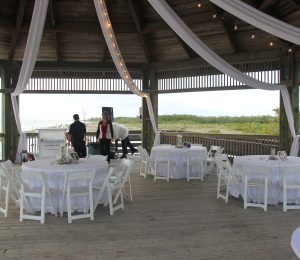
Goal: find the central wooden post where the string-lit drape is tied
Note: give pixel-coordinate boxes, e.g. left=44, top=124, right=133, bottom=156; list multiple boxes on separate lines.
left=142, top=69, right=158, bottom=152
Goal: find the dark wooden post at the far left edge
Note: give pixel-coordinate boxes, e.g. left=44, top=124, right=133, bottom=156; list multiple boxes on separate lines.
left=1, top=65, right=19, bottom=162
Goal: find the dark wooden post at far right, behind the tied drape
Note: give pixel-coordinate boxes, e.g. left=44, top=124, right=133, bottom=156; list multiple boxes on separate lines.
left=279, top=53, right=299, bottom=153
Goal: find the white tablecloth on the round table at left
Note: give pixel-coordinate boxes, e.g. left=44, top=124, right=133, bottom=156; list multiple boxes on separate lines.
left=21, top=158, right=108, bottom=212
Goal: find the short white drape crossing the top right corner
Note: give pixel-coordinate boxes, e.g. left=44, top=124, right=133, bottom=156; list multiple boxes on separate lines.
left=209, top=0, right=300, bottom=45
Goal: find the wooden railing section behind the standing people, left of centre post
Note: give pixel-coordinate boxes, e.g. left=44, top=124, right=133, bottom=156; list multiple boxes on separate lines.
left=26, top=131, right=142, bottom=153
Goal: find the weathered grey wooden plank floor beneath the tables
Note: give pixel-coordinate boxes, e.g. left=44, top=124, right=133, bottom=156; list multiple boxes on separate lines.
left=0, top=158, right=300, bottom=260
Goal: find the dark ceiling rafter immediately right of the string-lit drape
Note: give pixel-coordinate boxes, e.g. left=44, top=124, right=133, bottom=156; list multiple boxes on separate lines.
left=127, top=0, right=153, bottom=63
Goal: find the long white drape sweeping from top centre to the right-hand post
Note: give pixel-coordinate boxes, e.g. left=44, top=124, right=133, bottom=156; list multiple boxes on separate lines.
left=148, top=0, right=299, bottom=156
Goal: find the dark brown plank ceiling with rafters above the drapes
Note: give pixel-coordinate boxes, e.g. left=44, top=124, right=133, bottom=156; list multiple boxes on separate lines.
left=0, top=0, right=300, bottom=63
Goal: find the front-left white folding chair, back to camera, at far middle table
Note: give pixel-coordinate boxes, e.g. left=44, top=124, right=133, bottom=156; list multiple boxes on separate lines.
left=154, top=151, right=170, bottom=182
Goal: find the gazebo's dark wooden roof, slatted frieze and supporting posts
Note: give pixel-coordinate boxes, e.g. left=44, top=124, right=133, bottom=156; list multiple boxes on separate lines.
left=0, top=0, right=300, bottom=159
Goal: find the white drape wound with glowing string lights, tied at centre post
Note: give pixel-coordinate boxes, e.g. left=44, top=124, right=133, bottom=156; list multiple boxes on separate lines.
left=94, top=0, right=157, bottom=138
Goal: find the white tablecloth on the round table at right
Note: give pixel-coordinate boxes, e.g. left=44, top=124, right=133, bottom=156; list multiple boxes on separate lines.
left=230, top=155, right=300, bottom=205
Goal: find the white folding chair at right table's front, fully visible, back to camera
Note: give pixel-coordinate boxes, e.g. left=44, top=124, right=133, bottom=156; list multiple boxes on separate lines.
left=242, top=166, right=270, bottom=211
